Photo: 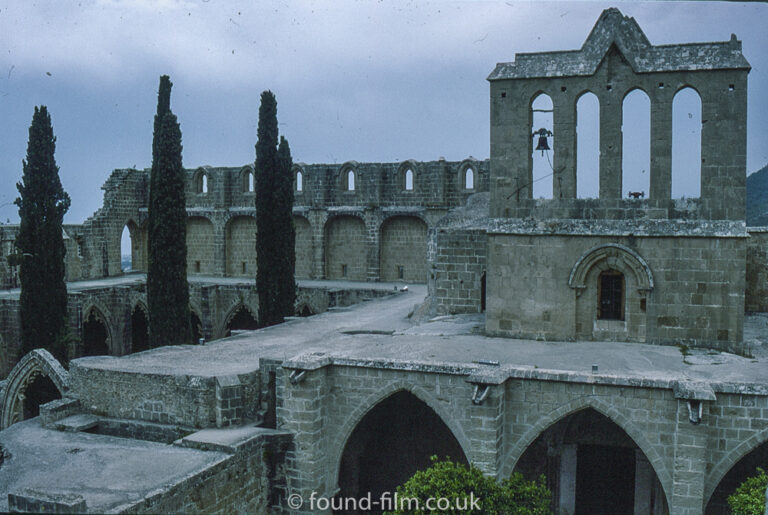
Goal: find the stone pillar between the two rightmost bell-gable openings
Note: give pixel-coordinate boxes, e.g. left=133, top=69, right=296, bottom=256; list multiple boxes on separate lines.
left=649, top=89, right=672, bottom=200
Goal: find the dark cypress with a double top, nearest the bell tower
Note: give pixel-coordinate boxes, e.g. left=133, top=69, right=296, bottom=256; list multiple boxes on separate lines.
left=256, top=91, right=296, bottom=326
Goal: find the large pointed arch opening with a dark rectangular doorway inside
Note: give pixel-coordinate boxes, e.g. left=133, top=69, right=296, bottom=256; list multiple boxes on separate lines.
left=515, top=408, right=669, bottom=515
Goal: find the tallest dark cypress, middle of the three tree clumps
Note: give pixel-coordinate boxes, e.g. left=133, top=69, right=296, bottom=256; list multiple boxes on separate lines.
left=147, top=75, right=192, bottom=347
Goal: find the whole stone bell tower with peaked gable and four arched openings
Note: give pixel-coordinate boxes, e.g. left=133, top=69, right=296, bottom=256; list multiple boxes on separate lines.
left=486, top=9, right=750, bottom=350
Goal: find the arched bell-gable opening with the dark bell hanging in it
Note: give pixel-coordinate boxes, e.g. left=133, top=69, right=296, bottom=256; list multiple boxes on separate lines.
left=531, top=93, right=555, bottom=198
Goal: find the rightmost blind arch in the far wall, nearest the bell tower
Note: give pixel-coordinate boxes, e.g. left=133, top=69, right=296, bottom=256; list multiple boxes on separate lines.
left=379, top=215, right=428, bottom=283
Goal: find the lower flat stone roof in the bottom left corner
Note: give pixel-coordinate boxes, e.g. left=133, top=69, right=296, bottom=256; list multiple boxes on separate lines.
left=0, top=418, right=228, bottom=513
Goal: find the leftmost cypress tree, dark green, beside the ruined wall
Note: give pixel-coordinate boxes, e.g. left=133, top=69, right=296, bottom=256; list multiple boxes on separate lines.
left=15, top=106, right=70, bottom=363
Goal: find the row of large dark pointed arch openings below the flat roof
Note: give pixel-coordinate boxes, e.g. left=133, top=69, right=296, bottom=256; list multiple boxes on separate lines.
left=336, top=390, right=768, bottom=515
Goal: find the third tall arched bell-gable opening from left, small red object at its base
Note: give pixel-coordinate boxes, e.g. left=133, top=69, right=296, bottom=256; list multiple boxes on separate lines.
left=621, top=89, right=651, bottom=198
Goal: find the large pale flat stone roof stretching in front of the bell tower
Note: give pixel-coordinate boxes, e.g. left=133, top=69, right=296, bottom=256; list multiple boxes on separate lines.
left=73, top=285, right=768, bottom=394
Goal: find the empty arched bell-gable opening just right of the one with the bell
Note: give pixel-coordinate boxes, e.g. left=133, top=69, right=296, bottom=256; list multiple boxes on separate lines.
left=576, top=93, right=600, bottom=198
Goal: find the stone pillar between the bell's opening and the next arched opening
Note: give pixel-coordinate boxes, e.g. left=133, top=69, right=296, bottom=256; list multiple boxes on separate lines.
left=552, top=94, right=576, bottom=198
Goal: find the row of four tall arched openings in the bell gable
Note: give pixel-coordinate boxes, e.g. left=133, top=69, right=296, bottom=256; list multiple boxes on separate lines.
left=531, top=84, right=702, bottom=198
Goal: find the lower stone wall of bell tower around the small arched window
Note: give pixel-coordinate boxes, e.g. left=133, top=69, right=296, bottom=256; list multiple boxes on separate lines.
left=486, top=232, right=745, bottom=351
